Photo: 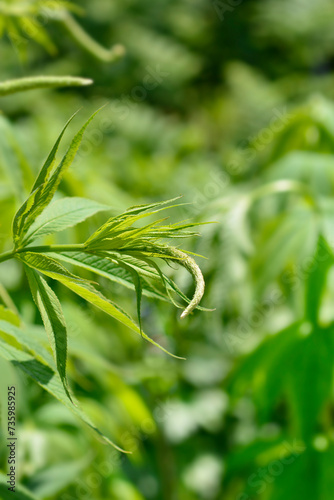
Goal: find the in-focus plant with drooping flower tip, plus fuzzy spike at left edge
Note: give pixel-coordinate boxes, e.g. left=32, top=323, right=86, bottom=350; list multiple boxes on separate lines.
left=0, top=77, right=204, bottom=452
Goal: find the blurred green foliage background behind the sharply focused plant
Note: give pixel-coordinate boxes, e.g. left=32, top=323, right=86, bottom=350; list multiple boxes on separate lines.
left=0, top=0, right=334, bottom=500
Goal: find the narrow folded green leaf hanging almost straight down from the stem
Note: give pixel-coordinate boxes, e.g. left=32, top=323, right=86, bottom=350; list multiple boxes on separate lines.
left=25, top=266, right=69, bottom=395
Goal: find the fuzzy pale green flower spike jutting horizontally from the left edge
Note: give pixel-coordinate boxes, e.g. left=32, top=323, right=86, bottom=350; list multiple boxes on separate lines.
left=0, top=76, right=93, bottom=97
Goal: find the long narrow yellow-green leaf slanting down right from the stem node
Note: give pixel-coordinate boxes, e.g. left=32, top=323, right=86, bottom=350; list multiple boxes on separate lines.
left=17, top=252, right=182, bottom=359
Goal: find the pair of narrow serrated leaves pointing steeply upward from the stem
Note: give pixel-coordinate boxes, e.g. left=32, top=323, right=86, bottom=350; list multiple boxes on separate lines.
left=13, top=111, right=98, bottom=246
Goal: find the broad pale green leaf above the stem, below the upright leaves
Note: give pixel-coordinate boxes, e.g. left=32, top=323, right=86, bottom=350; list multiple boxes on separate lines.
left=23, top=197, right=110, bottom=245
